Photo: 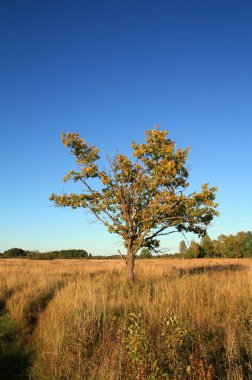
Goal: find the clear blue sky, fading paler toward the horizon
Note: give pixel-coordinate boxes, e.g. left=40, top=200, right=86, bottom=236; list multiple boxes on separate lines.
left=0, top=0, right=252, bottom=254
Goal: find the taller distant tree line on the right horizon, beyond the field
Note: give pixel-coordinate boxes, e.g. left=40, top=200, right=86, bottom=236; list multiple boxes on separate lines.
left=179, top=231, right=252, bottom=259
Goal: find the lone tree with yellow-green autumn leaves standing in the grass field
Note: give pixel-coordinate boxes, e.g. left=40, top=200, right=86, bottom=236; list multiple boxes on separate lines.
left=50, top=128, right=218, bottom=281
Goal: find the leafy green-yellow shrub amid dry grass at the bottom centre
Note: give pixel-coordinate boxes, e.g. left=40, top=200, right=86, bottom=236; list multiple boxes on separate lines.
left=124, top=311, right=194, bottom=380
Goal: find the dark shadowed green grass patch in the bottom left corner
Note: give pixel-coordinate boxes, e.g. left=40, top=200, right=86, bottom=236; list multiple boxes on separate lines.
left=0, top=311, right=30, bottom=380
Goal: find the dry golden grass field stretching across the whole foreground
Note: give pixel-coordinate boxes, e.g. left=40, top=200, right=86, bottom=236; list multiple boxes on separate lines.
left=0, top=259, right=252, bottom=380
